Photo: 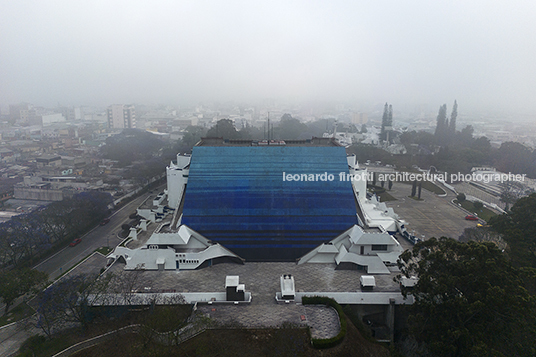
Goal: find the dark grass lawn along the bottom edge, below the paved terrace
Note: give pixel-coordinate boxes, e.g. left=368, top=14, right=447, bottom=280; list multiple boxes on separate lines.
left=74, top=314, right=390, bottom=357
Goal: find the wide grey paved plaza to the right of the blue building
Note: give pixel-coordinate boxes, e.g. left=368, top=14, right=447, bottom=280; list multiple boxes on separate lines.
left=386, top=183, right=478, bottom=239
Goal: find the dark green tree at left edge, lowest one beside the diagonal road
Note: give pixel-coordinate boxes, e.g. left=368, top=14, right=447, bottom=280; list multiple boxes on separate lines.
left=0, top=268, right=48, bottom=314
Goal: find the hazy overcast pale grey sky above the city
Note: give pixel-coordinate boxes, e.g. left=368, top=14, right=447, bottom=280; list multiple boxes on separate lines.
left=0, top=0, right=536, bottom=111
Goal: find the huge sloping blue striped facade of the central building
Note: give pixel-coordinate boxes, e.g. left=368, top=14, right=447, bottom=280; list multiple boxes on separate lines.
left=182, top=146, right=357, bottom=260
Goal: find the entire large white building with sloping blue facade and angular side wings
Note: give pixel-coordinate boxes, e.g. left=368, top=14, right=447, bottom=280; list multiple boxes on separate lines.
left=112, top=138, right=407, bottom=274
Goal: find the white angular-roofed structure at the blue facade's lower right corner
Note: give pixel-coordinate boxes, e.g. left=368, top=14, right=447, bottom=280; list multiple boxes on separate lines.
left=298, top=225, right=404, bottom=274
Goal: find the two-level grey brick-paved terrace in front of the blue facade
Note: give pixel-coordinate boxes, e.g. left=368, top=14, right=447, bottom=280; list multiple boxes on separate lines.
left=107, top=262, right=398, bottom=338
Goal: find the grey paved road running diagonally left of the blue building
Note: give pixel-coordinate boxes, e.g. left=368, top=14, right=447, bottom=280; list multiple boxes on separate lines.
left=34, top=189, right=158, bottom=280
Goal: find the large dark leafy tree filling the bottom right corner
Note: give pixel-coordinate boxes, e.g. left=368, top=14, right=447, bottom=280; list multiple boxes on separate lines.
left=397, top=238, right=536, bottom=356
